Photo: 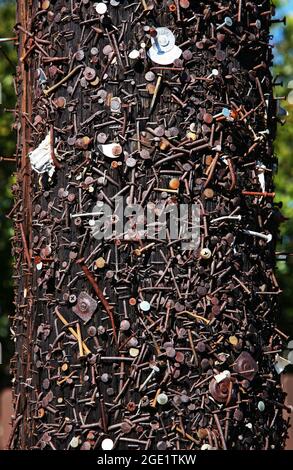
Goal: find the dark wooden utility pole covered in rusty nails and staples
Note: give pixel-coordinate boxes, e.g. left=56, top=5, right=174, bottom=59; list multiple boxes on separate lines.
left=10, top=0, right=287, bottom=450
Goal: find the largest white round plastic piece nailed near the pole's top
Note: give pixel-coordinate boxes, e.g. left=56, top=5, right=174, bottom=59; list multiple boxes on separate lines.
left=148, top=27, right=182, bottom=65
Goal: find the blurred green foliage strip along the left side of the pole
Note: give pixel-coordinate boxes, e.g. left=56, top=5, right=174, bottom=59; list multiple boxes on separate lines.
left=0, top=1, right=17, bottom=388
